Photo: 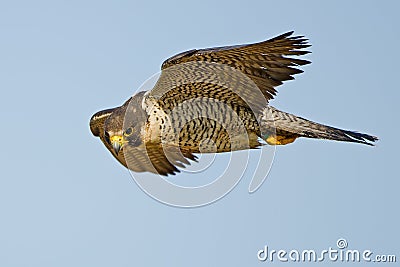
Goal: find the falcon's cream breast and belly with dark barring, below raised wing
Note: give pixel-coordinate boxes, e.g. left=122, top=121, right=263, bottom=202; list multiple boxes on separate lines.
left=147, top=97, right=260, bottom=153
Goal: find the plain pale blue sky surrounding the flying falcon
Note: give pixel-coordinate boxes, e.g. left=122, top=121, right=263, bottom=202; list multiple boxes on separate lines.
left=0, top=1, right=400, bottom=267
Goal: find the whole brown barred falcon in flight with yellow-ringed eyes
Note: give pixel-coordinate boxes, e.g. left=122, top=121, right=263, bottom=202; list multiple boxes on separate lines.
left=90, top=32, right=378, bottom=175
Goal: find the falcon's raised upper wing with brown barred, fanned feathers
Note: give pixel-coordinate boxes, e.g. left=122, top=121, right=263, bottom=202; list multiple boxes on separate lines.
left=148, top=32, right=310, bottom=112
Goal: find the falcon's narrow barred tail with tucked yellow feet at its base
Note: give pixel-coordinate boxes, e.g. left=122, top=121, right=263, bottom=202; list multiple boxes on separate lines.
left=261, top=106, right=378, bottom=146
